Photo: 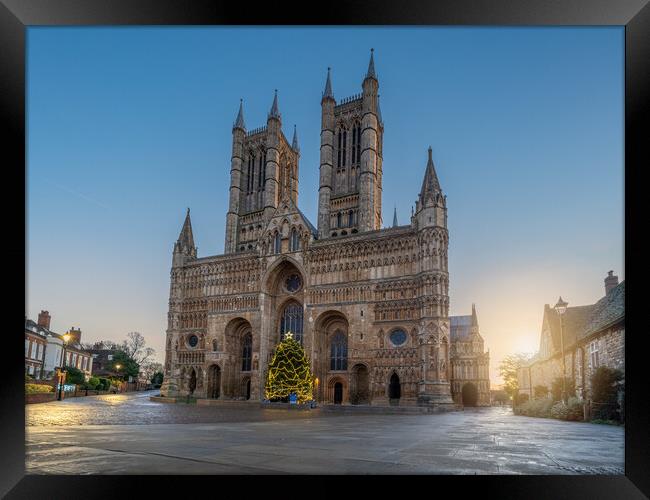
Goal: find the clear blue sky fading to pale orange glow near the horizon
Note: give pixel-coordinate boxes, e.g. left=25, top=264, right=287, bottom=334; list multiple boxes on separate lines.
left=26, top=27, right=624, bottom=380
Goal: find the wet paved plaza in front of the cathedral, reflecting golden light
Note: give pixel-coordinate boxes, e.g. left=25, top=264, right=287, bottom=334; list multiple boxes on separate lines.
left=26, top=393, right=624, bottom=474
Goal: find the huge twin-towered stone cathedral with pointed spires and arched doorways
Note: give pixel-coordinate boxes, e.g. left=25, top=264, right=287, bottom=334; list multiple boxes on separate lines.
left=161, top=52, right=490, bottom=407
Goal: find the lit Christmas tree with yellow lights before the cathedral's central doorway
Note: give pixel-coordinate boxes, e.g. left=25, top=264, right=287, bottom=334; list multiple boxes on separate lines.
left=265, top=332, right=313, bottom=403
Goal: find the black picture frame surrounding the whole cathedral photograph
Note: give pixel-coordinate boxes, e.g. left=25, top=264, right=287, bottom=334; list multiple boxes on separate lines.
left=0, top=0, right=650, bottom=499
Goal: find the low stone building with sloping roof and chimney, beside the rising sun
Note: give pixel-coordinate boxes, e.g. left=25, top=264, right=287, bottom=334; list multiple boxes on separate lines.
left=517, top=271, right=625, bottom=401
